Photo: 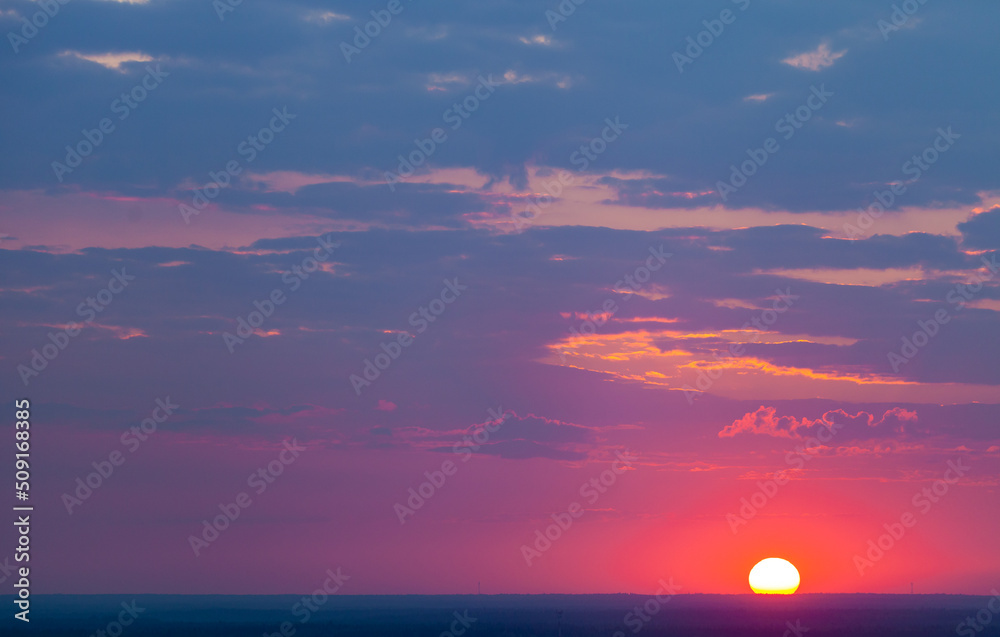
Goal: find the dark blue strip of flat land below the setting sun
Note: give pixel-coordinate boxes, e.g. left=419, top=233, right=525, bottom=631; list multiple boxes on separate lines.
left=0, top=595, right=1000, bottom=637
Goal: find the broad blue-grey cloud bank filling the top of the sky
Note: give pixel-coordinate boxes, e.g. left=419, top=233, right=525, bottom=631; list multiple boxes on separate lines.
left=0, top=0, right=1000, bottom=216
